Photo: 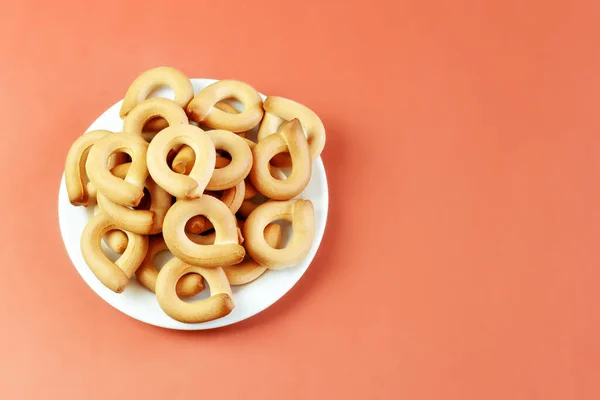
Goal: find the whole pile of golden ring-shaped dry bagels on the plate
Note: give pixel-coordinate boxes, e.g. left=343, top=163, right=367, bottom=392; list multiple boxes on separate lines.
left=65, top=67, right=325, bottom=323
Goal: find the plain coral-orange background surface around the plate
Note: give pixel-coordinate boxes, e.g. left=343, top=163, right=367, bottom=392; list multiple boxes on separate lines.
left=0, top=0, right=600, bottom=400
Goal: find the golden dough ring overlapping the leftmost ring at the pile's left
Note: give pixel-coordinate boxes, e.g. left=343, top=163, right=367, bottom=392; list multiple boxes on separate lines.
left=86, top=134, right=148, bottom=207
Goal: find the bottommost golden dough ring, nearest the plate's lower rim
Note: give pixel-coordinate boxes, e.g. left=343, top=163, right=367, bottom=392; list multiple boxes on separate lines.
left=156, top=258, right=235, bottom=323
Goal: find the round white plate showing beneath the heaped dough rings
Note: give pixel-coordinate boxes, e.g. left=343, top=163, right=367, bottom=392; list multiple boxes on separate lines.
left=58, top=79, right=329, bottom=330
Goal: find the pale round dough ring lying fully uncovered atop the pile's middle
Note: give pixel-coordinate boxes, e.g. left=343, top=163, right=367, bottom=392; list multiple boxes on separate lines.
left=147, top=124, right=216, bottom=199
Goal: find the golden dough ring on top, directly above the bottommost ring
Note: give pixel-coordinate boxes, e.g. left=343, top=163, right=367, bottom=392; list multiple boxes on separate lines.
left=163, top=196, right=246, bottom=267
